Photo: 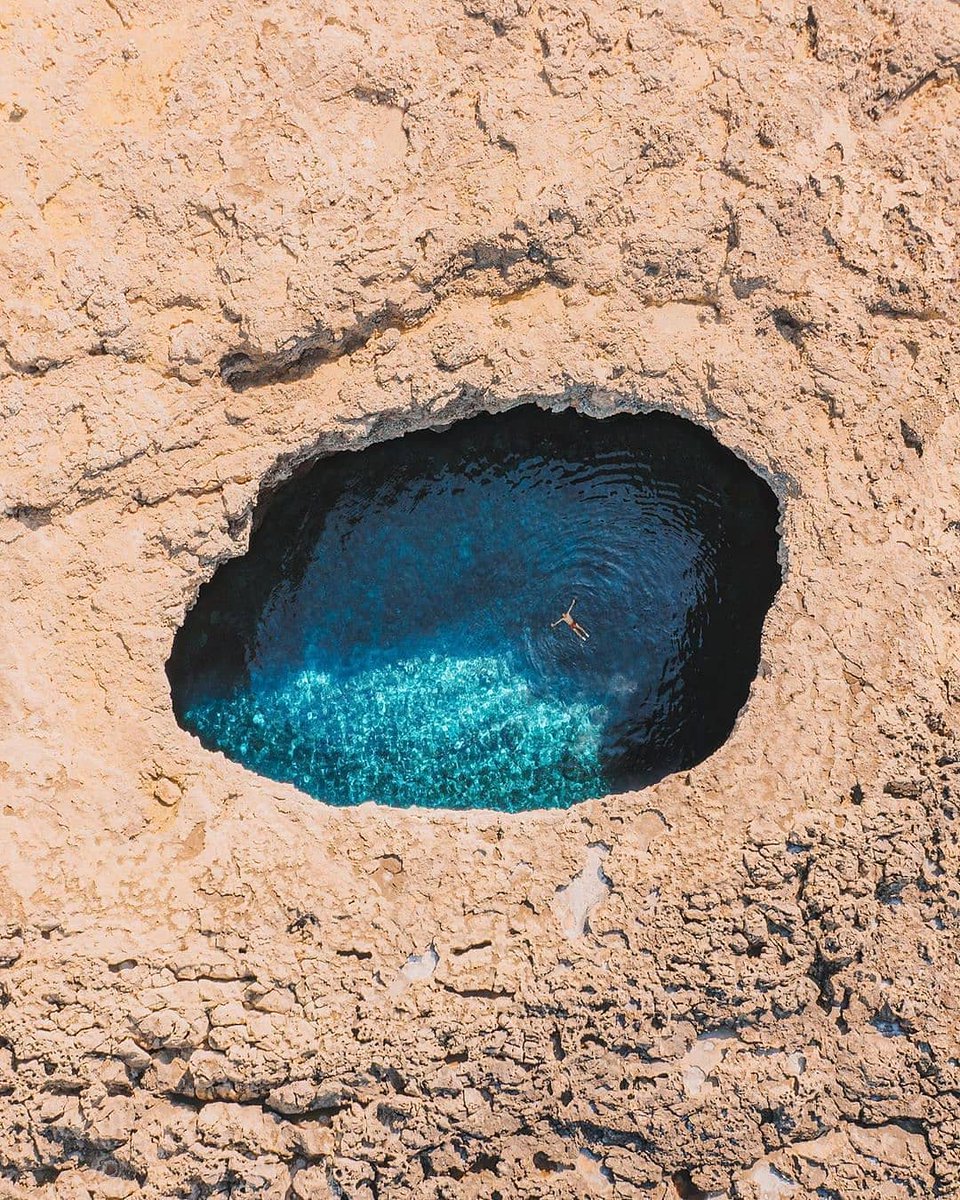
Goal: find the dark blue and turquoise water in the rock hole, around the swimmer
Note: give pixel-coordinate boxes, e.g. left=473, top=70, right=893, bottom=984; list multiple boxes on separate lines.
left=168, top=406, right=780, bottom=811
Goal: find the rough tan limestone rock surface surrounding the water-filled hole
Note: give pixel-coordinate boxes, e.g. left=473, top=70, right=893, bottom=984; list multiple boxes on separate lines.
left=0, top=0, right=960, bottom=1200
